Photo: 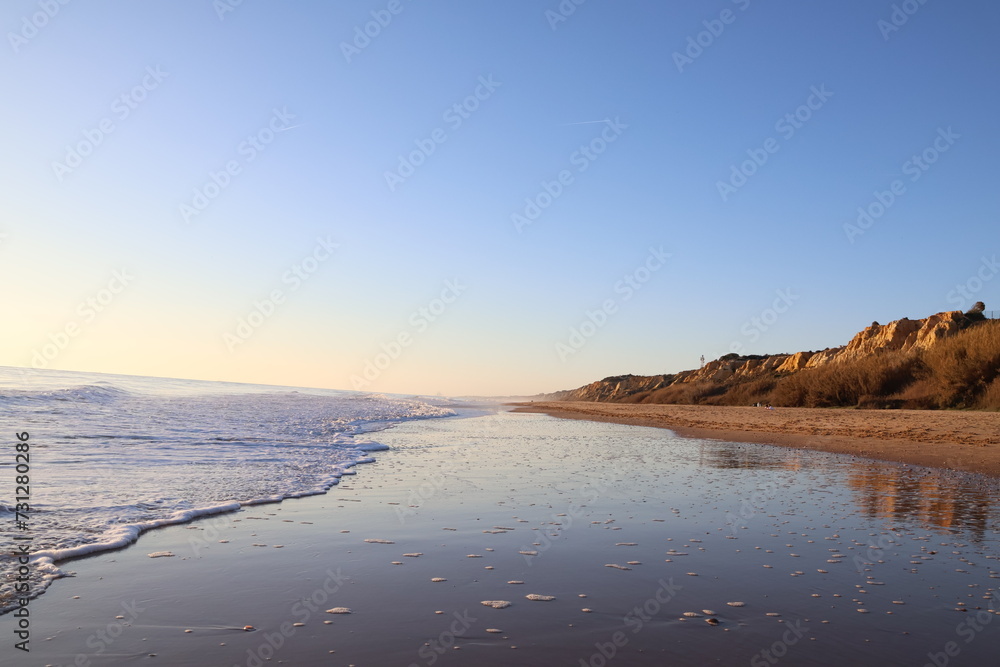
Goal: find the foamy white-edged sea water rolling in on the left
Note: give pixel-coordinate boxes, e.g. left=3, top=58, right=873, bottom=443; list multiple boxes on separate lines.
left=0, top=368, right=456, bottom=612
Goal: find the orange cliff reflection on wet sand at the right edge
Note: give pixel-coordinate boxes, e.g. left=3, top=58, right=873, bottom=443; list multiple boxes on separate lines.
left=847, top=467, right=997, bottom=539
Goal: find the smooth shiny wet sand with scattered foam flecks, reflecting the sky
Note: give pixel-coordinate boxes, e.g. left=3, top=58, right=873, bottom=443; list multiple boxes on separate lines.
left=7, top=413, right=1000, bottom=667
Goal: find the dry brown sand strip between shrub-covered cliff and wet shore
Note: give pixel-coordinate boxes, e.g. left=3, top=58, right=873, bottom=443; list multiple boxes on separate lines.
left=515, top=402, right=1000, bottom=477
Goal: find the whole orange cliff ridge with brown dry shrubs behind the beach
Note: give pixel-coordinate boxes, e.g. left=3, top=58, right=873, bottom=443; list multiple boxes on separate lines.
left=559, top=313, right=1000, bottom=410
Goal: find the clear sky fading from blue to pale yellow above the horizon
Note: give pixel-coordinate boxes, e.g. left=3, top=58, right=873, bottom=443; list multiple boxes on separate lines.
left=0, top=0, right=1000, bottom=396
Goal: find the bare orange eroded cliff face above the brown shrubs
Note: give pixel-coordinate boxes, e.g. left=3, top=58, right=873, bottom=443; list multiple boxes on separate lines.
left=546, top=310, right=969, bottom=402
